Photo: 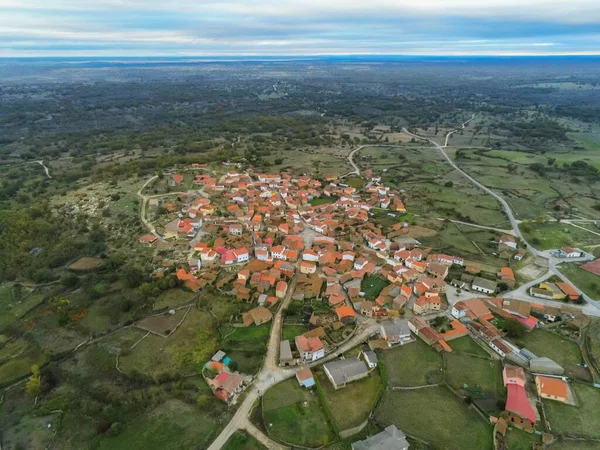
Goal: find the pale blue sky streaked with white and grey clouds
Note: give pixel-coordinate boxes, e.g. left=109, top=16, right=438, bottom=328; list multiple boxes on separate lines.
left=0, top=0, right=600, bottom=57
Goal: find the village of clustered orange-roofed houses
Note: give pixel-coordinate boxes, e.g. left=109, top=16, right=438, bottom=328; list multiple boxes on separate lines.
left=129, top=163, right=600, bottom=449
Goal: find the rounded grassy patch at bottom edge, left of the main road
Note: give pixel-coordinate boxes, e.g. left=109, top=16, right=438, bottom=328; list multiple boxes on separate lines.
left=96, top=400, right=220, bottom=450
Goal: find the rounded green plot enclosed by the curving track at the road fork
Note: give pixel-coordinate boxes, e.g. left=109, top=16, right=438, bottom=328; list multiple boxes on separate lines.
left=262, top=378, right=335, bottom=447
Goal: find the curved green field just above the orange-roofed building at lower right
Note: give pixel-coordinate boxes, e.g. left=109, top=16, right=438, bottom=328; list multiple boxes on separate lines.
left=515, top=330, right=591, bottom=381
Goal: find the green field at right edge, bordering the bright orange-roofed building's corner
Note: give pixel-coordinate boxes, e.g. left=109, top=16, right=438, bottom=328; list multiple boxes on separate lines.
left=544, top=383, right=600, bottom=439
